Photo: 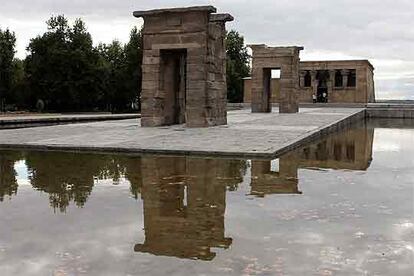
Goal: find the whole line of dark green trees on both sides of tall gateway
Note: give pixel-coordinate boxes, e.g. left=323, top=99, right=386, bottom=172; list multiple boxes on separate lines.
left=0, top=15, right=250, bottom=112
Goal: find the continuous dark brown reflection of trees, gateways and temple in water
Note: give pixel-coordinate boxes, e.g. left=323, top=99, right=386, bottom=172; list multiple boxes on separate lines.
left=0, top=122, right=374, bottom=260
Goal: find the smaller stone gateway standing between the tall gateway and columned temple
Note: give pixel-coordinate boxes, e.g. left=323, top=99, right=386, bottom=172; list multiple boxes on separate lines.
left=248, top=44, right=303, bottom=113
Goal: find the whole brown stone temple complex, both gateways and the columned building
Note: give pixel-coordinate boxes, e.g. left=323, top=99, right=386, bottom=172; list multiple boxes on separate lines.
left=134, top=6, right=375, bottom=124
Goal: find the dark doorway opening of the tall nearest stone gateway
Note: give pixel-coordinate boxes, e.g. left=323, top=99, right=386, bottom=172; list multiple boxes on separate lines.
left=160, top=49, right=187, bottom=125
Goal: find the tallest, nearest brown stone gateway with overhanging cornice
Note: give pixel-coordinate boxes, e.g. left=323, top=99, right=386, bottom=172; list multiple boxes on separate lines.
left=134, top=6, right=233, bottom=127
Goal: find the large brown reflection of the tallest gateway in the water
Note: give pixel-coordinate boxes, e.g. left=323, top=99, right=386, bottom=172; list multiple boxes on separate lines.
left=135, top=157, right=244, bottom=260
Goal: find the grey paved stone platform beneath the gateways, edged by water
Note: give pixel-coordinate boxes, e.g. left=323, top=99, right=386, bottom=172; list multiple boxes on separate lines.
left=0, top=108, right=365, bottom=158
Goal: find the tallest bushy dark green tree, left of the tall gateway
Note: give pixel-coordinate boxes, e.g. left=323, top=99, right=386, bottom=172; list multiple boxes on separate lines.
left=25, top=15, right=100, bottom=111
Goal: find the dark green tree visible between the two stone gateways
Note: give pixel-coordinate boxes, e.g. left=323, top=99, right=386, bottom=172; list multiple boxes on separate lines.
left=226, top=30, right=250, bottom=103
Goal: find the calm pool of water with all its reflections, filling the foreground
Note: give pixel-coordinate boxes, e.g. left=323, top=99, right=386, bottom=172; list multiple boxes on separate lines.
left=0, top=120, right=414, bottom=275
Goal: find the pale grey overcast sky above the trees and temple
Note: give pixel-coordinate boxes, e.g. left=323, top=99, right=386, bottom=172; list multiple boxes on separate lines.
left=0, top=0, right=414, bottom=100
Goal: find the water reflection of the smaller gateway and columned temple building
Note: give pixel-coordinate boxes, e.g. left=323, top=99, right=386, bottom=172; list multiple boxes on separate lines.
left=251, top=124, right=374, bottom=197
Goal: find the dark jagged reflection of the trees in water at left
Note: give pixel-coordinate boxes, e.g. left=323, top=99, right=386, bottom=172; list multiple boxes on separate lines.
left=0, top=151, right=146, bottom=212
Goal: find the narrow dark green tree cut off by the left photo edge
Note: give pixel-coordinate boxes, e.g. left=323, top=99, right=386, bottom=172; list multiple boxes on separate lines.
left=0, top=29, right=16, bottom=111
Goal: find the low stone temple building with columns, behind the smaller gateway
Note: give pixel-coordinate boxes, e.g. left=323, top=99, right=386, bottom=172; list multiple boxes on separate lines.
left=244, top=60, right=375, bottom=103
